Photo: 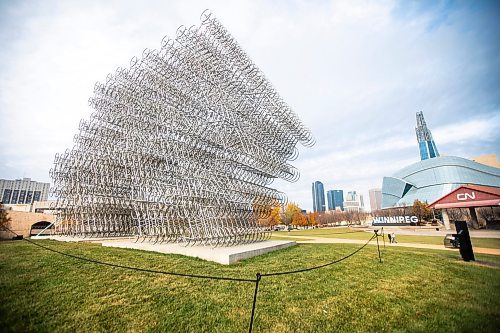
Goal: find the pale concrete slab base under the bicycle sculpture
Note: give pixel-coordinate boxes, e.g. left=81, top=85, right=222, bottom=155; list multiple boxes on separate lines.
left=102, top=240, right=297, bottom=265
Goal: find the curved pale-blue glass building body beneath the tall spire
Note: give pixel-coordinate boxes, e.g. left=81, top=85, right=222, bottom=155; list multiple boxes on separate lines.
left=382, top=156, right=500, bottom=208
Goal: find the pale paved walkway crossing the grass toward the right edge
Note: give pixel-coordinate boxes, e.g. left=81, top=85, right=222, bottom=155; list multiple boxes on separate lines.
left=273, top=234, right=500, bottom=255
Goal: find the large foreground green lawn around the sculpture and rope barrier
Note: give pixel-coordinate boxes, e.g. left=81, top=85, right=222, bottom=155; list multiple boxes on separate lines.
left=0, top=240, right=500, bottom=333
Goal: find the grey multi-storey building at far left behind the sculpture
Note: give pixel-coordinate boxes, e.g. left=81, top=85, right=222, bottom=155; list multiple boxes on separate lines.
left=0, top=178, right=50, bottom=205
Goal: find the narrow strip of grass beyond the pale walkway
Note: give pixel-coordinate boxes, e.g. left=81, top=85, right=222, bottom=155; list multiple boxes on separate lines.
left=273, top=228, right=500, bottom=249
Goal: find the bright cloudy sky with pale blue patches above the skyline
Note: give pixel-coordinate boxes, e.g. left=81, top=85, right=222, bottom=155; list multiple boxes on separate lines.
left=0, top=0, right=500, bottom=211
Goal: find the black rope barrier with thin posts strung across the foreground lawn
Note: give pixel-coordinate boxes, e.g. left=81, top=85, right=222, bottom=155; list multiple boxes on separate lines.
left=0, top=226, right=383, bottom=333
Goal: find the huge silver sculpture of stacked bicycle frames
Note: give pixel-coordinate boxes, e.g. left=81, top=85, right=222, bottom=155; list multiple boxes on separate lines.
left=50, top=12, right=314, bottom=246
